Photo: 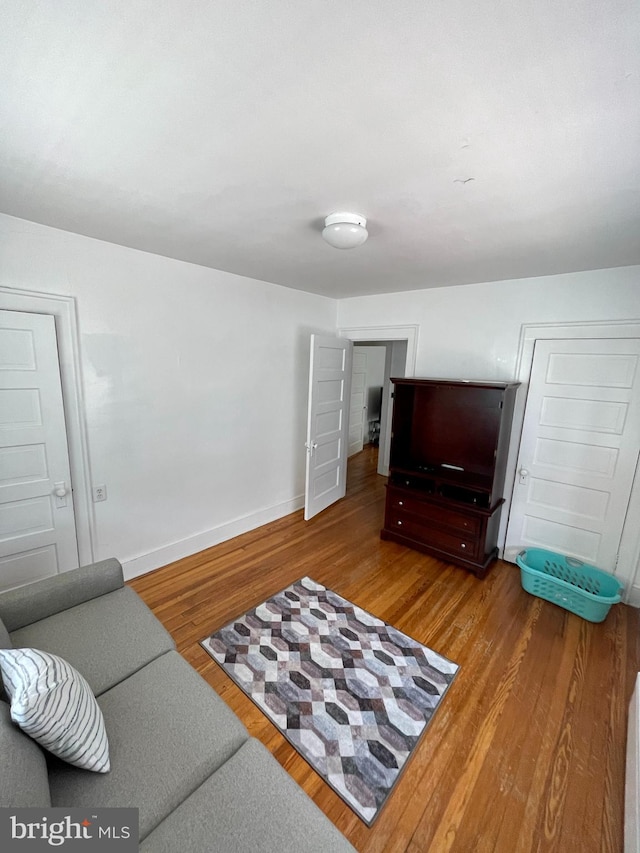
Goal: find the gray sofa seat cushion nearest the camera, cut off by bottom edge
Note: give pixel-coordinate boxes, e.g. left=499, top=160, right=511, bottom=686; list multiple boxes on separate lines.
left=140, top=738, right=354, bottom=853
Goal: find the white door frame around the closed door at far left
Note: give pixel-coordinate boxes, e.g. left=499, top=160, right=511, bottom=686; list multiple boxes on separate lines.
left=0, top=286, right=97, bottom=566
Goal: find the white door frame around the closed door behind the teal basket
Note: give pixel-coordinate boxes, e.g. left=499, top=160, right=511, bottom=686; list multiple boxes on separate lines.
left=498, top=320, right=640, bottom=607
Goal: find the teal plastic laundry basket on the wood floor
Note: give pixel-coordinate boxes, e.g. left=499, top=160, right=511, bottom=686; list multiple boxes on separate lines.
left=516, top=548, right=624, bottom=622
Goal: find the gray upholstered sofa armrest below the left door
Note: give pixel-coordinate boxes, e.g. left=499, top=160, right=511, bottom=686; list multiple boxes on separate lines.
left=0, top=557, right=124, bottom=631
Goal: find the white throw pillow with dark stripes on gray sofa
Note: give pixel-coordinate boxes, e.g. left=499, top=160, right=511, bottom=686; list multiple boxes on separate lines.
left=0, top=649, right=111, bottom=773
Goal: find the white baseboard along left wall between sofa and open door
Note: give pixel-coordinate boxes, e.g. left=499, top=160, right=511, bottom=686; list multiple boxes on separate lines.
left=121, top=495, right=304, bottom=580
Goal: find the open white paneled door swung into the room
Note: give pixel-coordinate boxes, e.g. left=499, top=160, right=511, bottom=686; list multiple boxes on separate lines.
left=304, top=335, right=353, bottom=520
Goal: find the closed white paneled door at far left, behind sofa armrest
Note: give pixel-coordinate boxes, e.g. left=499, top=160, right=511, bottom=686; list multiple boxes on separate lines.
left=0, top=311, right=79, bottom=589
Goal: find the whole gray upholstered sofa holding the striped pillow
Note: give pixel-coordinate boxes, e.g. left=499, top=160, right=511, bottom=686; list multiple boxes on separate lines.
left=0, top=559, right=354, bottom=853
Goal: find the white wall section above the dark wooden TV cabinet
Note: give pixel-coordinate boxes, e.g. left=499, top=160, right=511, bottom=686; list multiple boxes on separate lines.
left=338, top=266, right=640, bottom=380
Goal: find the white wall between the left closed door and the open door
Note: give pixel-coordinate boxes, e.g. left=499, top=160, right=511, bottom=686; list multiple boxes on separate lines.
left=0, top=215, right=336, bottom=576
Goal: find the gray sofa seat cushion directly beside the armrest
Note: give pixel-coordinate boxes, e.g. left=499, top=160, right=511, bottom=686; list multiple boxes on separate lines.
left=11, top=587, right=175, bottom=696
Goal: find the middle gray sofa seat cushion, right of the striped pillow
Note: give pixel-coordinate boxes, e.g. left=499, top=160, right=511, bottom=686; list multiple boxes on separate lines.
left=49, top=652, right=248, bottom=849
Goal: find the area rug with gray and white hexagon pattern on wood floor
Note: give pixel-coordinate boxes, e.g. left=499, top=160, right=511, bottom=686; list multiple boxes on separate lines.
left=201, top=577, right=458, bottom=826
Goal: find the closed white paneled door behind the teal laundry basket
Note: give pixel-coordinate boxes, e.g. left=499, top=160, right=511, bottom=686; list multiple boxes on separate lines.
left=505, top=338, right=640, bottom=572
